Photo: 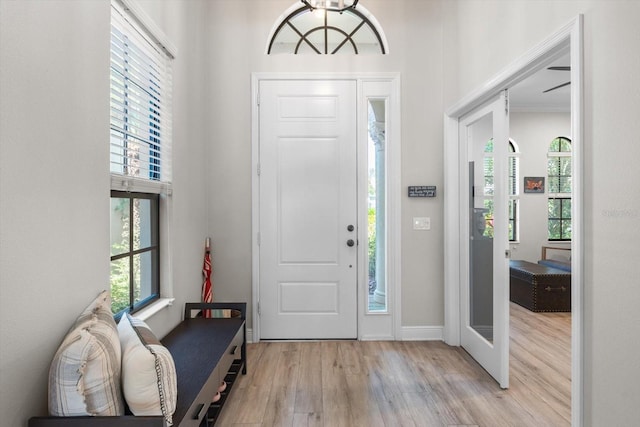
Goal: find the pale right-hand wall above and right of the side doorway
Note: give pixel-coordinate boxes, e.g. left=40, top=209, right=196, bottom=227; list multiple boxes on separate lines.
left=443, top=0, right=640, bottom=426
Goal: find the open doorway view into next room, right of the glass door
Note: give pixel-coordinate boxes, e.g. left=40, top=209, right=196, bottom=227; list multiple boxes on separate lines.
left=509, top=51, right=573, bottom=426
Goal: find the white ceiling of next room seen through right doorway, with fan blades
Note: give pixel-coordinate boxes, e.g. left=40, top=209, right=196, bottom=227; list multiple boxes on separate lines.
left=509, top=54, right=571, bottom=112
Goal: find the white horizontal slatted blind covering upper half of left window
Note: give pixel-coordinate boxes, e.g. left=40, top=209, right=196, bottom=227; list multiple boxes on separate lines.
left=109, top=2, right=172, bottom=193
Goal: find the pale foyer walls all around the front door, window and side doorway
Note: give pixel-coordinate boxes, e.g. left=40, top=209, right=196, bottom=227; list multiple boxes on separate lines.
left=5, top=0, right=640, bottom=427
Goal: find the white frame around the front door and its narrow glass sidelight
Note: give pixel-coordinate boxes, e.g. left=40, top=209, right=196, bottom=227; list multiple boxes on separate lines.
left=251, top=73, right=402, bottom=342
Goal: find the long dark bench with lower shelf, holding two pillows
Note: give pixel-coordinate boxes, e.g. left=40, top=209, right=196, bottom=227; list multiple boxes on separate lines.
left=29, top=303, right=247, bottom=427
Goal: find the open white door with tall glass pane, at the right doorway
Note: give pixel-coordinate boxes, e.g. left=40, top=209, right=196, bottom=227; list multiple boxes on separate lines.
left=459, top=91, right=509, bottom=388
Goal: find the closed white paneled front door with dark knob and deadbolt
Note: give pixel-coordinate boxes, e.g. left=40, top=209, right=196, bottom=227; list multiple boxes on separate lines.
left=259, top=80, right=357, bottom=339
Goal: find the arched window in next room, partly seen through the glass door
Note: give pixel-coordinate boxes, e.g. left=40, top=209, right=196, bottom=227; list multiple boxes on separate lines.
left=482, top=138, right=519, bottom=242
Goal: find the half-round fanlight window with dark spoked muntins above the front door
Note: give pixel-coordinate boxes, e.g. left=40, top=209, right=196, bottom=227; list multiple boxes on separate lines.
left=267, top=2, right=388, bottom=55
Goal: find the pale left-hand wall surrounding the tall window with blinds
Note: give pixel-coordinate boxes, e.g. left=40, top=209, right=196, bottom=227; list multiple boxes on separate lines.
left=0, top=0, right=211, bottom=427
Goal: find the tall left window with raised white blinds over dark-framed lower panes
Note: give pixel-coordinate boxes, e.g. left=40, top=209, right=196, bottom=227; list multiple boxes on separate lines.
left=109, top=0, right=172, bottom=318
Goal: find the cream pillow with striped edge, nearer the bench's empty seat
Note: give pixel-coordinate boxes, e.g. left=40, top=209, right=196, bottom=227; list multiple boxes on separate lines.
left=118, top=314, right=178, bottom=425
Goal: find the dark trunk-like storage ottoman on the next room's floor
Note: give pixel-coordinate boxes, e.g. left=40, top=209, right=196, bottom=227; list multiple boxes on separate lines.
left=509, top=261, right=571, bottom=312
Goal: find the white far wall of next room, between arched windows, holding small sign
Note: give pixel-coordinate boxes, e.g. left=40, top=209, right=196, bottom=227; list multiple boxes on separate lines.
left=509, top=113, right=571, bottom=262
